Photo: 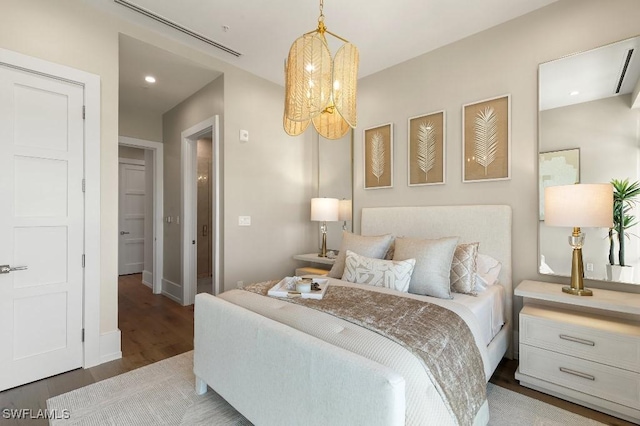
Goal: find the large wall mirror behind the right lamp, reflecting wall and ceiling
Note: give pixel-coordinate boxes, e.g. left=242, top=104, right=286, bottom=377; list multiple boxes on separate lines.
left=538, top=37, right=640, bottom=284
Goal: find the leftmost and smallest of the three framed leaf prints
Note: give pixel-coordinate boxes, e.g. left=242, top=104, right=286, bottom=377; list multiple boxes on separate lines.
left=364, top=123, right=393, bottom=189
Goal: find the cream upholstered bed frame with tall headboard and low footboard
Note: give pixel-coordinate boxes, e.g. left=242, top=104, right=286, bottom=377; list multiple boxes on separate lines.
left=194, top=206, right=513, bottom=425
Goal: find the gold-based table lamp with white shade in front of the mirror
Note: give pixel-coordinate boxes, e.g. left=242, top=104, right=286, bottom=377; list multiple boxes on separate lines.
left=544, top=183, right=613, bottom=296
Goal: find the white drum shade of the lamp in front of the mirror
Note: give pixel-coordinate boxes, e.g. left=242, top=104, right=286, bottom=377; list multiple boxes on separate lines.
left=544, top=183, right=613, bottom=228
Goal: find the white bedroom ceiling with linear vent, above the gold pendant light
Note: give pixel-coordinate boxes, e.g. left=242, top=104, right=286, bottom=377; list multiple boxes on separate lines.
left=96, top=0, right=556, bottom=108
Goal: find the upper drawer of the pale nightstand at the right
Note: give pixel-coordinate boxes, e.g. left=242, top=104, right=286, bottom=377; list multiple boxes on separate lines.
left=520, top=304, right=640, bottom=373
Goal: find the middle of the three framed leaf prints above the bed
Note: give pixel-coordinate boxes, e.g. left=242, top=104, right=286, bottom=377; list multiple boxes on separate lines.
left=407, top=111, right=445, bottom=186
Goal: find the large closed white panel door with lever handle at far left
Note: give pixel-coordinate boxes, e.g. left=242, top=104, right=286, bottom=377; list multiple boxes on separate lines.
left=0, top=66, right=84, bottom=391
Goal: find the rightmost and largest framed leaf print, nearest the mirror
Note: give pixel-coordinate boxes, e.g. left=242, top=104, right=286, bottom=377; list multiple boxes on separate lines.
left=462, top=95, right=511, bottom=182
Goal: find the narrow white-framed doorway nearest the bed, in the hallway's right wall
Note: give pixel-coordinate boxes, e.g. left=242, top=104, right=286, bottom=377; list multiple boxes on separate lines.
left=181, top=116, right=221, bottom=305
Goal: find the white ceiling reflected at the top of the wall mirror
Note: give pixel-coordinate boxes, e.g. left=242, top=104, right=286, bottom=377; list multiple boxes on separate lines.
left=539, top=37, right=640, bottom=111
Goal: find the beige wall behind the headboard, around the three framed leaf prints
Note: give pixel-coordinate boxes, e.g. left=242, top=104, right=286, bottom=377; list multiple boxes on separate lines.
left=354, top=0, right=640, bottom=328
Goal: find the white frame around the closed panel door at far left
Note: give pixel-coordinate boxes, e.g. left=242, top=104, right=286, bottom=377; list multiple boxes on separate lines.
left=0, top=48, right=102, bottom=368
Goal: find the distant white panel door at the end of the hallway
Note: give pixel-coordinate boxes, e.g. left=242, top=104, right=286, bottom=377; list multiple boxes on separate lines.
left=118, top=163, right=146, bottom=275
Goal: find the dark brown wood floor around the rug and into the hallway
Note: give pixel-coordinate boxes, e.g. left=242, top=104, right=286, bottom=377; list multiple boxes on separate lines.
left=0, top=274, right=633, bottom=426
